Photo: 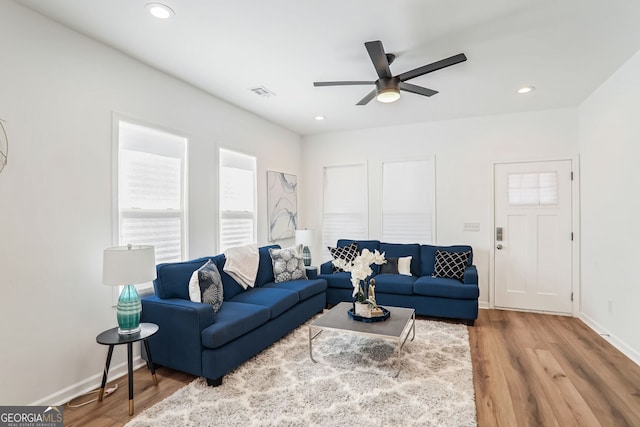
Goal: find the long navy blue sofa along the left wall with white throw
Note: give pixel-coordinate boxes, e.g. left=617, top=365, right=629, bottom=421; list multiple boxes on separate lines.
left=141, top=245, right=327, bottom=386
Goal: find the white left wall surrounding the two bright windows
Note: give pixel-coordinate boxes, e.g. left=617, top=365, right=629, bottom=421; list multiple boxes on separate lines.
left=0, top=1, right=301, bottom=405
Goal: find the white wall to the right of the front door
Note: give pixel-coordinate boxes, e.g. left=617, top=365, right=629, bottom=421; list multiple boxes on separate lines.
left=579, top=52, right=640, bottom=364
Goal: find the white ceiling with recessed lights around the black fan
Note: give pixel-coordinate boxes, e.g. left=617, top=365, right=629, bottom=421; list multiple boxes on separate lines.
left=17, top=0, right=640, bottom=135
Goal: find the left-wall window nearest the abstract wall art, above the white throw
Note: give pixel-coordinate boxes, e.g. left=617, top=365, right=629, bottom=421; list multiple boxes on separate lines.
left=219, top=148, right=256, bottom=252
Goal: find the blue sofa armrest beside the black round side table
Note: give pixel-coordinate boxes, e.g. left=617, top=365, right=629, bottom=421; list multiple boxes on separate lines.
left=141, top=295, right=214, bottom=375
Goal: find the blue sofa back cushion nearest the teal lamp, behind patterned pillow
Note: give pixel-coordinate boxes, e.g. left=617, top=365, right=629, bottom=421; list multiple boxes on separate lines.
left=153, top=257, right=215, bottom=300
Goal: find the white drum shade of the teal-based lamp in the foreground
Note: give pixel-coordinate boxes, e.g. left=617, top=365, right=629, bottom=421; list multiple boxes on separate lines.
left=102, top=245, right=156, bottom=286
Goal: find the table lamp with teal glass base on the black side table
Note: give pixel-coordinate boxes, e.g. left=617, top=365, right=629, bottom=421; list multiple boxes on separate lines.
left=102, top=245, right=156, bottom=335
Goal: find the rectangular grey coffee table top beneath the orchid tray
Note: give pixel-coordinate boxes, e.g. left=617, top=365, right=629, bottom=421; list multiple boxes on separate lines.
left=310, top=302, right=415, bottom=338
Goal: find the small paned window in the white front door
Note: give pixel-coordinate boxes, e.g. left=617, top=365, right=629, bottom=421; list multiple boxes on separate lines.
left=508, top=172, right=558, bottom=206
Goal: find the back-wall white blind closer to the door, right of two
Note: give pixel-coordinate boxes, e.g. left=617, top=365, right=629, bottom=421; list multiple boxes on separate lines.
left=382, top=159, right=435, bottom=244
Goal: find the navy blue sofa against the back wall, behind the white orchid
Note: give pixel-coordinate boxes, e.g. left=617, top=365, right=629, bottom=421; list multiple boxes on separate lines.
left=318, top=239, right=480, bottom=326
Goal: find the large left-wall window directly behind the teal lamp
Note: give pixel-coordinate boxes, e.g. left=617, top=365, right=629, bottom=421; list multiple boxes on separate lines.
left=117, top=120, right=187, bottom=263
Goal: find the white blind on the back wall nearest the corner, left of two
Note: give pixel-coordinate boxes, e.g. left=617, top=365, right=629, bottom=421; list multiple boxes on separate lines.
left=322, top=164, right=369, bottom=259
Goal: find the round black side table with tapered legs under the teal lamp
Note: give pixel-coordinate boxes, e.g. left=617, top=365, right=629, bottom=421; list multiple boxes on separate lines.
left=96, top=323, right=160, bottom=415
